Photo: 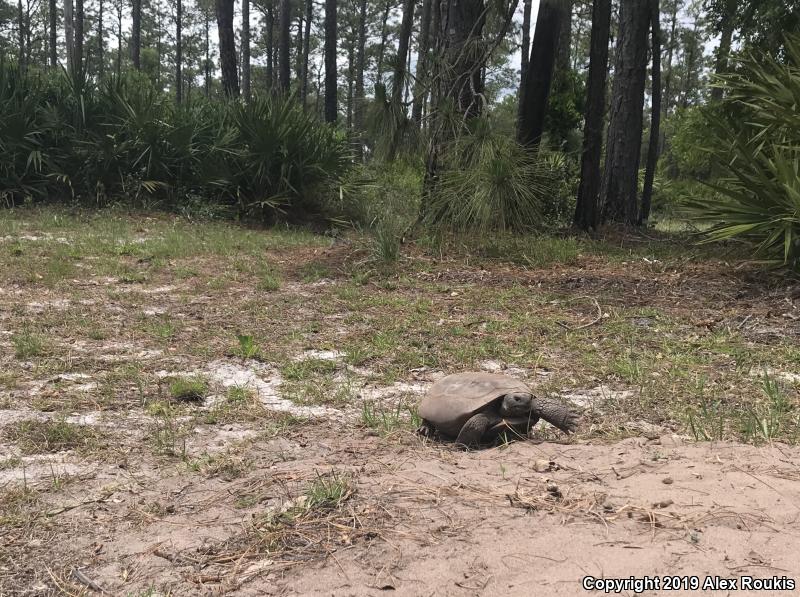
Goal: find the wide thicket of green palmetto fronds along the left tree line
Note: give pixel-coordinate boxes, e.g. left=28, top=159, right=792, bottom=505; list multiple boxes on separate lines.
left=0, top=63, right=350, bottom=217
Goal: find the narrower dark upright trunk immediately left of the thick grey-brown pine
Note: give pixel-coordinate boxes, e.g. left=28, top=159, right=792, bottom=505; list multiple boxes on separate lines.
left=574, top=0, right=611, bottom=230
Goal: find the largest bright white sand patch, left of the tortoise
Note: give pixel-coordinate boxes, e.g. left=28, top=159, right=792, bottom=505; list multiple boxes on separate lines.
left=205, top=361, right=344, bottom=418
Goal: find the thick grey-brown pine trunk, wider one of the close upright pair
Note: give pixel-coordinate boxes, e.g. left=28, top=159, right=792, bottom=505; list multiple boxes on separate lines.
left=600, top=0, right=650, bottom=226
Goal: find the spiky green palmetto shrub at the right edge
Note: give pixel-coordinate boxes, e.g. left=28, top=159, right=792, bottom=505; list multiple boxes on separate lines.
left=689, top=37, right=800, bottom=270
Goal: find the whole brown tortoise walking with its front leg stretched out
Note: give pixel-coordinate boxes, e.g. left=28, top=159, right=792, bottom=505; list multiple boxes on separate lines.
left=419, top=372, right=578, bottom=446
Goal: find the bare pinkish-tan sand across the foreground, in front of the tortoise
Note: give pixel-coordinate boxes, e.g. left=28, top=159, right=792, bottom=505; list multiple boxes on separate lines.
left=3, top=424, right=800, bottom=596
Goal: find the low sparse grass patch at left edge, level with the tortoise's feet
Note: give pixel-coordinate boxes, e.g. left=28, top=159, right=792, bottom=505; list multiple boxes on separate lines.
left=3, top=419, right=101, bottom=454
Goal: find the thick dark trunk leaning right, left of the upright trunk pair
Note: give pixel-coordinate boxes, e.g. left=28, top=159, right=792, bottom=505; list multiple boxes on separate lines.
left=517, top=0, right=569, bottom=146
